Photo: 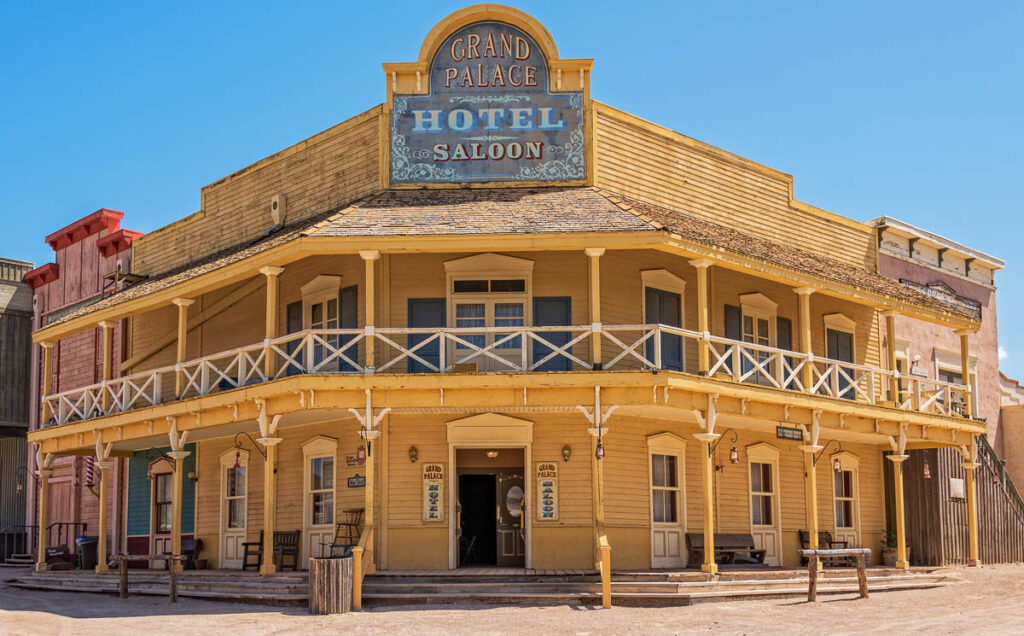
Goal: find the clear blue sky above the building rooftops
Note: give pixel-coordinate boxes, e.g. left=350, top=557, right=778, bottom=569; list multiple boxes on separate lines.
left=0, top=0, right=1024, bottom=379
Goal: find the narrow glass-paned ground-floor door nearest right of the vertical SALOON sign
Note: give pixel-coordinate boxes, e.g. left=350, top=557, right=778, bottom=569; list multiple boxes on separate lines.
left=650, top=453, right=685, bottom=567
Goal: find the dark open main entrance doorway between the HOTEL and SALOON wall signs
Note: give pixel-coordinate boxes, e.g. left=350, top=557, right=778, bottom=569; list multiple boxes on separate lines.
left=456, top=449, right=527, bottom=567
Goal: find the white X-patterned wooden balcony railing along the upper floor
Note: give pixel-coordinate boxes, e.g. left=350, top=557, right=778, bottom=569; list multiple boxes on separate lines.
left=43, top=325, right=971, bottom=425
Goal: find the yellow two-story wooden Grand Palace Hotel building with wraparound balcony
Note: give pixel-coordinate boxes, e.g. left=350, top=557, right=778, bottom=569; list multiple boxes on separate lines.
left=30, top=5, right=985, bottom=606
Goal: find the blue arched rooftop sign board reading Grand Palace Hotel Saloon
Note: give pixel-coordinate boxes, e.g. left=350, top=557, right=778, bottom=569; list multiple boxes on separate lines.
left=389, top=20, right=587, bottom=184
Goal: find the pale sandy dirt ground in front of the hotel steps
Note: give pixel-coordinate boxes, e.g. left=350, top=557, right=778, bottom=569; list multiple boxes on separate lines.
left=0, top=565, right=1024, bottom=636
